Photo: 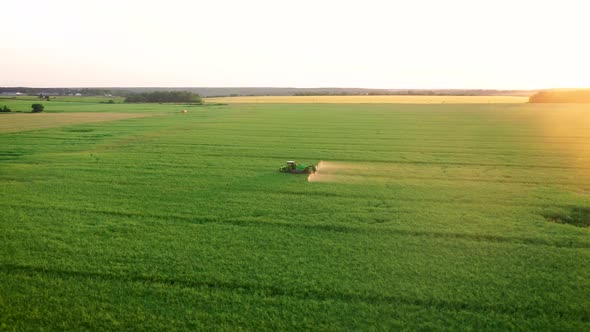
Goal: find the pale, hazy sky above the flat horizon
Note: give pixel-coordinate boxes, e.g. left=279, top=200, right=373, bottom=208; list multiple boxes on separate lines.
left=0, top=0, right=590, bottom=89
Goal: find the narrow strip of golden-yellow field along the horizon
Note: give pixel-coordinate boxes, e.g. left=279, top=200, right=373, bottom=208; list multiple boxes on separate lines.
left=206, top=95, right=528, bottom=104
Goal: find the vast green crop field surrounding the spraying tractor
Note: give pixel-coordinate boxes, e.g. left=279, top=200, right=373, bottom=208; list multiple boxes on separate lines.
left=0, top=97, right=590, bottom=331
